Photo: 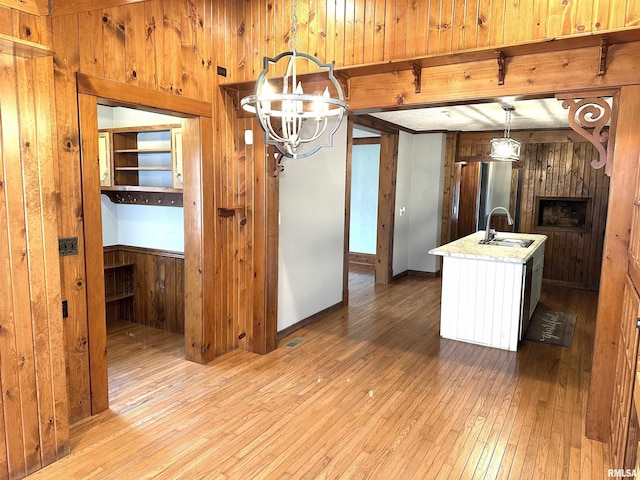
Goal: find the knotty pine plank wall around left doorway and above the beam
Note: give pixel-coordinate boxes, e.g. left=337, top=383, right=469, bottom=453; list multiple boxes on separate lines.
left=0, top=0, right=638, bottom=476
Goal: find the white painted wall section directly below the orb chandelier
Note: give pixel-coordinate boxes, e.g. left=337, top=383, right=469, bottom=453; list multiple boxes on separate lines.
left=278, top=121, right=347, bottom=331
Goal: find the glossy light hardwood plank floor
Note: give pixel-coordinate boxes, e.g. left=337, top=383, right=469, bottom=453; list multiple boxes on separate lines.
left=30, top=271, right=608, bottom=480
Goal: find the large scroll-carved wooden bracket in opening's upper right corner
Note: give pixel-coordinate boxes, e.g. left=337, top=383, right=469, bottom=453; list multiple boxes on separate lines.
left=556, top=95, right=613, bottom=176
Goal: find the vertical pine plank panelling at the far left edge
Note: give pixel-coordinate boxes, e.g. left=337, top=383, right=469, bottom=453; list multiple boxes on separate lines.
left=0, top=8, right=69, bottom=478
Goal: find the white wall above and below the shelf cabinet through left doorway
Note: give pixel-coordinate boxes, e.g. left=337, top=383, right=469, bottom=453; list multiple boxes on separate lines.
left=98, top=105, right=184, bottom=252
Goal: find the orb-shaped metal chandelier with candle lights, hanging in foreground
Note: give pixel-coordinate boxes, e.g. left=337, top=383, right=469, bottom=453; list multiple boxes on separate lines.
left=240, top=0, right=347, bottom=162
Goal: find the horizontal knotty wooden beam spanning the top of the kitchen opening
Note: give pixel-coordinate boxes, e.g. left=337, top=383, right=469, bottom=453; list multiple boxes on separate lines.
left=349, top=42, right=640, bottom=114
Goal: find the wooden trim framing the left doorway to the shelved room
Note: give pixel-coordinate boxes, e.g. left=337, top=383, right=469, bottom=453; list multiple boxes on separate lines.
left=78, top=79, right=215, bottom=415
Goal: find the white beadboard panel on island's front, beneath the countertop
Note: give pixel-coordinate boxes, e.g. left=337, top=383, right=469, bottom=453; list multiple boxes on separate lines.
left=440, top=257, right=524, bottom=351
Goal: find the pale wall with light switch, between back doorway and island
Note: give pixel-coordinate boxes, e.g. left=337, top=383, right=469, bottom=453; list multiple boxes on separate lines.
left=393, top=132, right=446, bottom=275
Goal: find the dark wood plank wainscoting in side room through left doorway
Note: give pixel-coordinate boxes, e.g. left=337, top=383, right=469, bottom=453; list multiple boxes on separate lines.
left=104, top=245, right=184, bottom=334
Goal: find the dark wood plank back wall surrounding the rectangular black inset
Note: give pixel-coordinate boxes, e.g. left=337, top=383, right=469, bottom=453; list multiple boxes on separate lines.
left=458, top=130, right=609, bottom=290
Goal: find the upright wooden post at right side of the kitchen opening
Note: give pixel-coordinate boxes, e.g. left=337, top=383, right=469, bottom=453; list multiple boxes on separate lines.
left=586, top=85, right=640, bottom=442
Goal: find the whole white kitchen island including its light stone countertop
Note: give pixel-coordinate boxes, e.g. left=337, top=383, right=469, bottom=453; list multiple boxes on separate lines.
left=429, top=231, right=547, bottom=351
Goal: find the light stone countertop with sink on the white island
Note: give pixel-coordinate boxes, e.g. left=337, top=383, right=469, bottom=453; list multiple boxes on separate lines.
left=429, top=230, right=547, bottom=263
